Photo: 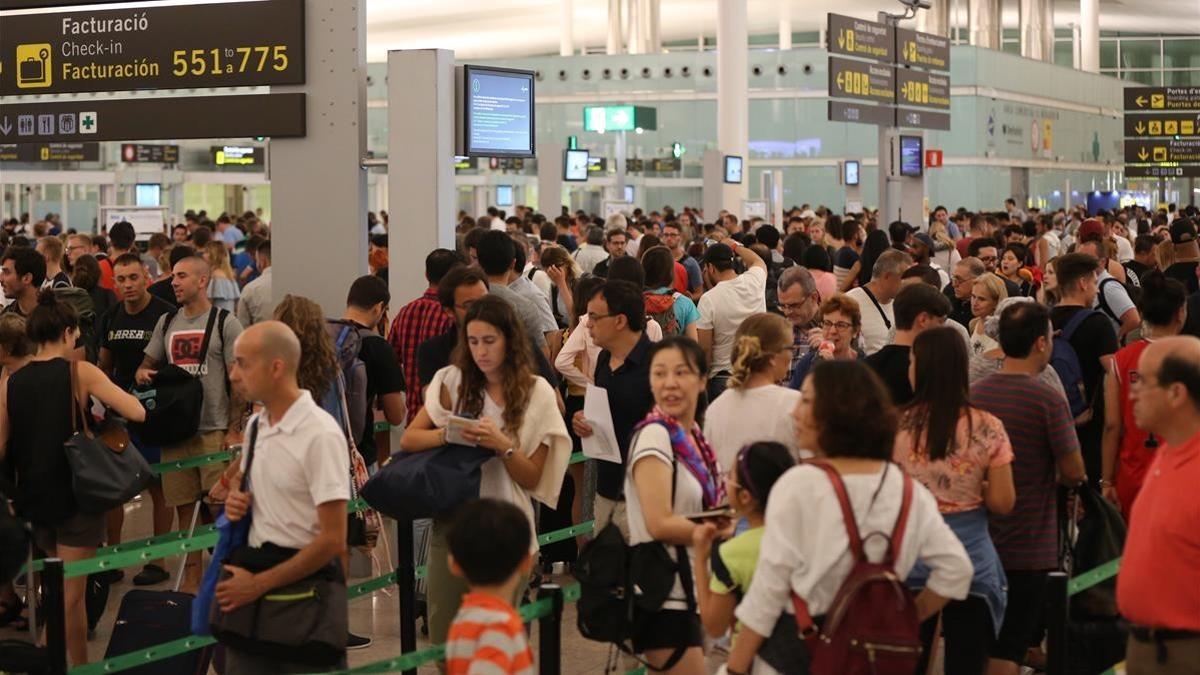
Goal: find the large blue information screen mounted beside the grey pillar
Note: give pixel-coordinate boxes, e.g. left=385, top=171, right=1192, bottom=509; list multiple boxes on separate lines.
left=461, top=66, right=534, bottom=157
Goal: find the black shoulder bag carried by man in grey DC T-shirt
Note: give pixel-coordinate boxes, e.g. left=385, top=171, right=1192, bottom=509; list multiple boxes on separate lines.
left=131, top=306, right=229, bottom=446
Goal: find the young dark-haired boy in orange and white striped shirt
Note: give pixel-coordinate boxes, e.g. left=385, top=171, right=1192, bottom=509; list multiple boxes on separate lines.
left=446, top=500, right=535, bottom=675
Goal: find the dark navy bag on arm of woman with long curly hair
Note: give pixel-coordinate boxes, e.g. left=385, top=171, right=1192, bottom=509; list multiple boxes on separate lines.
left=362, top=443, right=496, bottom=521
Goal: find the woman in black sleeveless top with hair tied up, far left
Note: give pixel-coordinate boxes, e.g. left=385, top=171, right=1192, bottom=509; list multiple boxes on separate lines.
left=0, top=289, right=146, bottom=665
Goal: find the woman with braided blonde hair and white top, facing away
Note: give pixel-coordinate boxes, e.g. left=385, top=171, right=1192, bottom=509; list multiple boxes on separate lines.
left=704, top=312, right=800, bottom=466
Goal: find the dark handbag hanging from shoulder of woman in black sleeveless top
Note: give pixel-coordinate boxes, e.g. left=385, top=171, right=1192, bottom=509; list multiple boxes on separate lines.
left=62, top=363, right=154, bottom=513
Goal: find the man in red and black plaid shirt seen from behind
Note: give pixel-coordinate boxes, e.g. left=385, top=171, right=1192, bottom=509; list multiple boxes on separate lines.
left=388, top=249, right=466, bottom=423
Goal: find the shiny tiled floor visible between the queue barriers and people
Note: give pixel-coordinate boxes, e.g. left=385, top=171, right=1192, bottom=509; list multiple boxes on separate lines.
left=0, top=492, right=608, bottom=675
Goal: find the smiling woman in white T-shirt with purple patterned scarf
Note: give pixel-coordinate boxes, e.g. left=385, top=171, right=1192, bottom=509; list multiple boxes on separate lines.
left=625, top=336, right=730, bottom=674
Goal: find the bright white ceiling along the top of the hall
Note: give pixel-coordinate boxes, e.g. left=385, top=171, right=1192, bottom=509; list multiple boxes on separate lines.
left=367, top=0, right=1200, bottom=61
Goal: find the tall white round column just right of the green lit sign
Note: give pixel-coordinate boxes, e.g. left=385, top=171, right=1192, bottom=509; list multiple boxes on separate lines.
left=704, top=0, right=750, bottom=212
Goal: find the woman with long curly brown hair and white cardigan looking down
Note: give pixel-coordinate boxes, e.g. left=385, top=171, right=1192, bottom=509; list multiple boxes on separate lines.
left=400, top=295, right=571, bottom=644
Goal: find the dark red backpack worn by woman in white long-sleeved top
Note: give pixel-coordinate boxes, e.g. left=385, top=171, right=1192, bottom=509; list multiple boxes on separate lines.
left=792, top=462, right=922, bottom=675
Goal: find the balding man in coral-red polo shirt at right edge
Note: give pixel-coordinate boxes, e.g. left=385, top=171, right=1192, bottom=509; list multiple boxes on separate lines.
left=1117, top=336, right=1200, bottom=675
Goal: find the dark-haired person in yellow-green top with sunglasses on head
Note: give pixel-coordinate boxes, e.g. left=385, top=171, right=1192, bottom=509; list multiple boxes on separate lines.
left=692, top=441, right=796, bottom=638
